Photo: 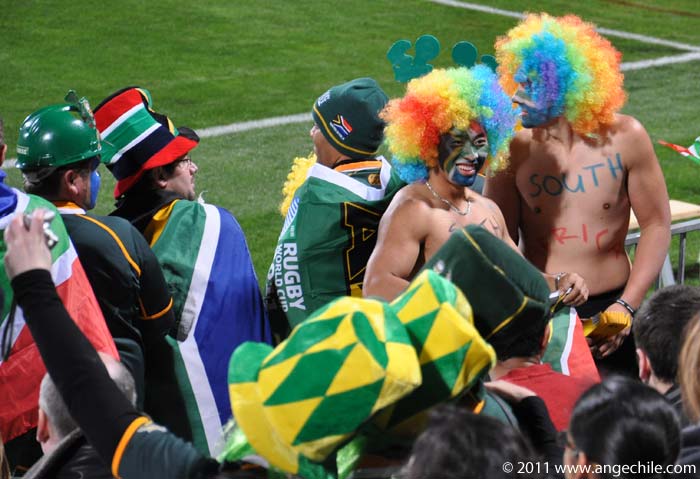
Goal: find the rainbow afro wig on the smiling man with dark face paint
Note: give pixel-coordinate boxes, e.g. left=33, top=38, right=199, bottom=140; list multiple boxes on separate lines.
left=381, top=65, right=517, bottom=183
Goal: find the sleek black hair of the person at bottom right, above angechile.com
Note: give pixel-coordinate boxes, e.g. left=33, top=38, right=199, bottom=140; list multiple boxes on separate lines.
left=569, top=376, right=680, bottom=478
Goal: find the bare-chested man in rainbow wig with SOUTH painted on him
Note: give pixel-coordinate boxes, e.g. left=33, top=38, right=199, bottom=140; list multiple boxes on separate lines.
left=484, top=13, right=670, bottom=372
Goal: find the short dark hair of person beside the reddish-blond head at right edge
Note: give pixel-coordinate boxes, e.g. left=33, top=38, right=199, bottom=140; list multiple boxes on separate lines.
left=632, top=284, right=700, bottom=383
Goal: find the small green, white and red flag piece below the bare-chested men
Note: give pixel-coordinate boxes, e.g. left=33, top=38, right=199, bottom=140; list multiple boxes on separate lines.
left=542, top=307, right=600, bottom=381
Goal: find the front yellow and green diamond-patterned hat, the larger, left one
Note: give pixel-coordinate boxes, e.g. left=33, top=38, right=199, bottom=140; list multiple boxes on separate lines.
left=226, top=297, right=421, bottom=477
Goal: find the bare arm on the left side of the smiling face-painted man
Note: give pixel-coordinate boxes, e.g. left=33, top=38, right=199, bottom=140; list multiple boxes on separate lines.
left=362, top=199, right=427, bottom=301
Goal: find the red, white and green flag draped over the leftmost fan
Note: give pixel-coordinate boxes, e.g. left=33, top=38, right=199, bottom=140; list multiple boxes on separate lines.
left=0, top=190, right=118, bottom=441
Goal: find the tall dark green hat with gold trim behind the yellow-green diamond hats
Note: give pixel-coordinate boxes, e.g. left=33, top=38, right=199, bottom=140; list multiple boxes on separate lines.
left=423, top=225, right=549, bottom=357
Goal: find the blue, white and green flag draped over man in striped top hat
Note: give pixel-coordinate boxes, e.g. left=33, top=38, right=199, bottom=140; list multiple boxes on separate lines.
left=146, top=200, right=270, bottom=455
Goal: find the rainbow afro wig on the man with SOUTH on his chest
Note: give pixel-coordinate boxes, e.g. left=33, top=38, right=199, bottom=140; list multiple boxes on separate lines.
left=495, top=13, right=626, bottom=135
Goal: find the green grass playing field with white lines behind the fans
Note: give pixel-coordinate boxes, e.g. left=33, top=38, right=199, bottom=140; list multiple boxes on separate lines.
left=0, top=0, right=700, bottom=280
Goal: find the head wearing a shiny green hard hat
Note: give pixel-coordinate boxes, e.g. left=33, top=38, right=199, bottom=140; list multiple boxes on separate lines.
left=17, top=92, right=102, bottom=210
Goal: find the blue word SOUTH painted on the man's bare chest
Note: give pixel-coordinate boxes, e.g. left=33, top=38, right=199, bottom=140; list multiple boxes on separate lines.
left=527, top=153, right=625, bottom=198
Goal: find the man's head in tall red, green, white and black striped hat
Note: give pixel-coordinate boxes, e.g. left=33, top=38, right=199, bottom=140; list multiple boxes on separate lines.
left=95, top=87, right=199, bottom=200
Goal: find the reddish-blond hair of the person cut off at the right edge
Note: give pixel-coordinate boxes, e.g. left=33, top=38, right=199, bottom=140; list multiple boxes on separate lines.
left=678, top=313, right=700, bottom=422
